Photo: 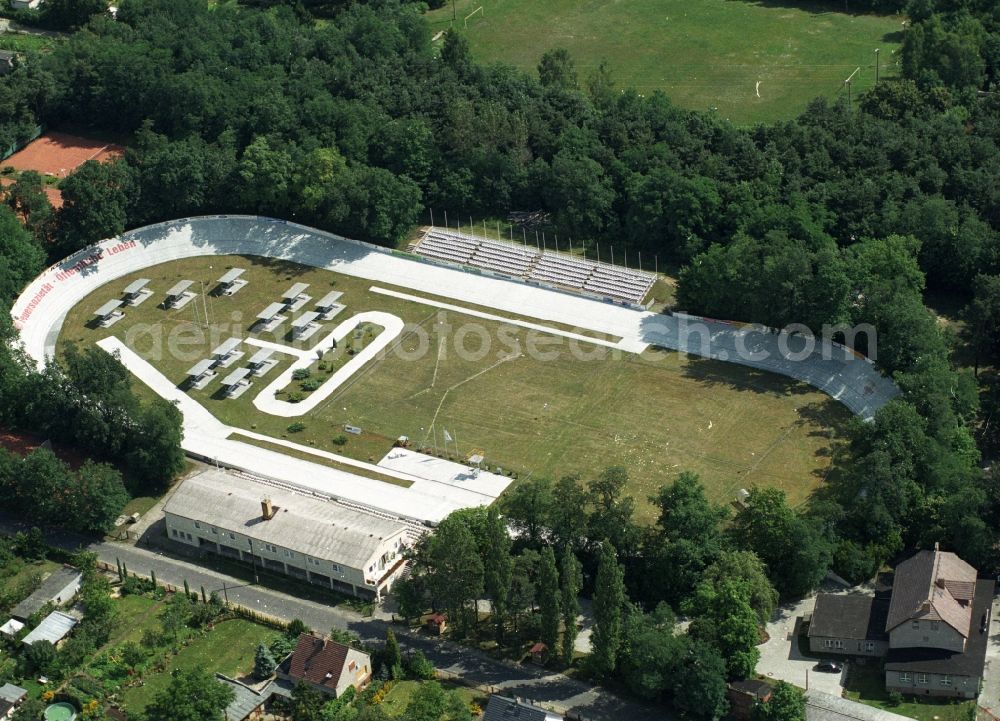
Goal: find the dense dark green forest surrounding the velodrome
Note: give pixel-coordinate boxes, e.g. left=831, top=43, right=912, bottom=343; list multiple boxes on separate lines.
left=0, top=0, right=1000, bottom=601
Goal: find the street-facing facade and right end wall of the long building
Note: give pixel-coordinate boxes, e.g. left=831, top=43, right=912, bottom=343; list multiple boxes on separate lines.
left=166, top=513, right=403, bottom=598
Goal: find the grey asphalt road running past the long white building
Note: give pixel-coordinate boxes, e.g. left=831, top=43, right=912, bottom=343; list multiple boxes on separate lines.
left=0, top=519, right=672, bottom=721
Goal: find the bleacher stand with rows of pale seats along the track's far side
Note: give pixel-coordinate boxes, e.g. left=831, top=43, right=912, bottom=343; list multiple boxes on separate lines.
left=415, top=228, right=656, bottom=303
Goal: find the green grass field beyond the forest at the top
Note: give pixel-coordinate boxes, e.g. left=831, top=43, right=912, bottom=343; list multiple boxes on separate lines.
left=429, top=0, right=903, bottom=124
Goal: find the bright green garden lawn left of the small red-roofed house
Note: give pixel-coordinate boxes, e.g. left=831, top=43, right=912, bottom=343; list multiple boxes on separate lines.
left=124, top=619, right=277, bottom=711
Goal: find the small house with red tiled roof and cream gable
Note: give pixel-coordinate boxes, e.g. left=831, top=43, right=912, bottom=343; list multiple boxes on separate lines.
left=277, top=633, right=372, bottom=698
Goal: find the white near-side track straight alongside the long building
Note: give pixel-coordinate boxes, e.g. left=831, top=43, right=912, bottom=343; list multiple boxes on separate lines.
left=97, top=337, right=509, bottom=523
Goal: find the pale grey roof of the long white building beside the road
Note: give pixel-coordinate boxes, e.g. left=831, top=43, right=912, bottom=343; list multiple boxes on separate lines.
left=164, top=470, right=405, bottom=570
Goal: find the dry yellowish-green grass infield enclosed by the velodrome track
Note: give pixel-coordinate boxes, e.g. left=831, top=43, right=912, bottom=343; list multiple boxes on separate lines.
left=60, top=257, right=849, bottom=520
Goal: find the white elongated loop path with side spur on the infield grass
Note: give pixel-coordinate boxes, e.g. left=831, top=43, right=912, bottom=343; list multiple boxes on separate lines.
left=245, top=310, right=404, bottom=418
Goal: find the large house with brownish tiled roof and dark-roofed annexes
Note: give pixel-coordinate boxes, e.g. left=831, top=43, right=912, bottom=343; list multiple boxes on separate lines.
left=809, top=544, right=995, bottom=698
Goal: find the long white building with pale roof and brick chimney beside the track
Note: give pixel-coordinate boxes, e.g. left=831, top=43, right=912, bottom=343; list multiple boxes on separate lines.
left=164, top=470, right=408, bottom=598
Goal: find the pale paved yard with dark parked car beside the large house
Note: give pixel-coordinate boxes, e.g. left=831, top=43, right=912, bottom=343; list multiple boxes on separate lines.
left=757, top=594, right=843, bottom=696
